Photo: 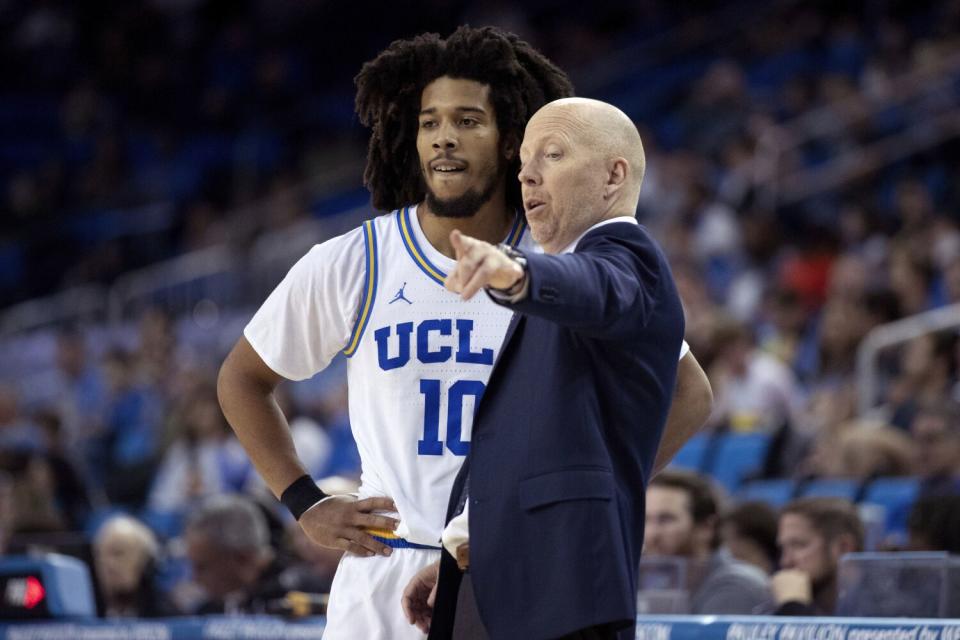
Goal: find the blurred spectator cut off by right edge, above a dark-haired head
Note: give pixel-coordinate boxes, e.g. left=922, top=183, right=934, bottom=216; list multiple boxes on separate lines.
left=910, top=399, right=960, bottom=496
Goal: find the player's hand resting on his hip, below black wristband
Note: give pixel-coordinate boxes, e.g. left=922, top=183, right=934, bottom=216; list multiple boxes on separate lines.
left=300, top=496, right=400, bottom=557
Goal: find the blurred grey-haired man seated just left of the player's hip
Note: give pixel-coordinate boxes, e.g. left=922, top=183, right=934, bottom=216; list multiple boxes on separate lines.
left=185, top=496, right=292, bottom=615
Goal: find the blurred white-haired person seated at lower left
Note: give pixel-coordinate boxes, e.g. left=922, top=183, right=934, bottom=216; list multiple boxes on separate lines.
left=93, top=516, right=179, bottom=618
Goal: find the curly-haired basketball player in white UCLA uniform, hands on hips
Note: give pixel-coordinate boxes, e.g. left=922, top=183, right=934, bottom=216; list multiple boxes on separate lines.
left=219, top=27, right=709, bottom=640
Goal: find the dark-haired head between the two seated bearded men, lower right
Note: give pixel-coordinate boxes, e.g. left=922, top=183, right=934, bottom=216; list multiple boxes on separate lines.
left=720, top=501, right=780, bottom=575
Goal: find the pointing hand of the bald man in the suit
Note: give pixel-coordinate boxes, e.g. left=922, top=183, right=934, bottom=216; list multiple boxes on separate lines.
left=443, top=230, right=523, bottom=300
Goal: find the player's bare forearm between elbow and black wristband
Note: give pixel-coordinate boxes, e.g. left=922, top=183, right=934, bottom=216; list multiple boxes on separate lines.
left=217, top=358, right=306, bottom=498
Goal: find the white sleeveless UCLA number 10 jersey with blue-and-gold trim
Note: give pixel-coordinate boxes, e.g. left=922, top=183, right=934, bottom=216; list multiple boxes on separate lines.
left=344, top=207, right=536, bottom=545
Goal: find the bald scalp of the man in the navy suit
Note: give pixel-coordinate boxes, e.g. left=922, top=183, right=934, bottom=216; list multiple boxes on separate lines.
left=531, top=98, right=647, bottom=198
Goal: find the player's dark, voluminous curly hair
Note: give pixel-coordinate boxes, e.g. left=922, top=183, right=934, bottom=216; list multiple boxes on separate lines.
left=354, top=26, right=573, bottom=211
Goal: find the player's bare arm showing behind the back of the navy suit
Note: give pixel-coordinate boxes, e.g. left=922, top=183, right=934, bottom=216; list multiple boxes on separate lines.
left=653, top=353, right=713, bottom=475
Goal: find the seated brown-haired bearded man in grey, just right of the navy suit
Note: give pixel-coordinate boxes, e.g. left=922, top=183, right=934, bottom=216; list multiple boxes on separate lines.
left=643, top=470, right=771, bottom=615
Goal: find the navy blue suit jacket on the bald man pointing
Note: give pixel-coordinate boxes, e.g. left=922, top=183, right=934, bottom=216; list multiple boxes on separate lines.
left=430, top=222, right=684, bottom=638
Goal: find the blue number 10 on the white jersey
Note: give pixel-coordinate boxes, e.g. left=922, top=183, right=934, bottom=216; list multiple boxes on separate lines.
left=417, top=380, right=486, bottom=456
